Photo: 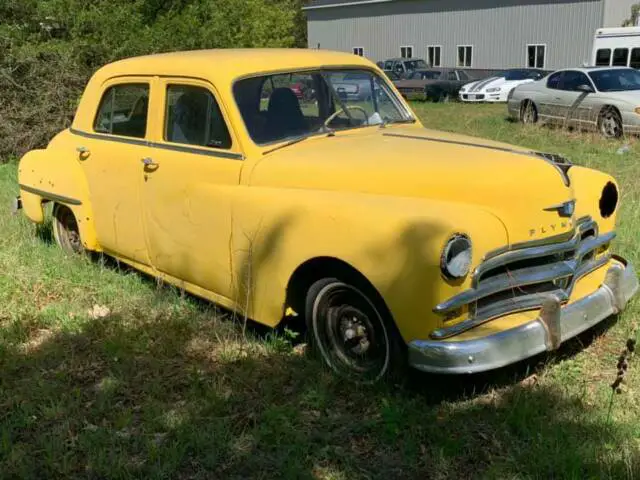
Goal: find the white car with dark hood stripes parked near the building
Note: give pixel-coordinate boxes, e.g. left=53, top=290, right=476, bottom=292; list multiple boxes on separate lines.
left=459, top=68, right=545, bottom=102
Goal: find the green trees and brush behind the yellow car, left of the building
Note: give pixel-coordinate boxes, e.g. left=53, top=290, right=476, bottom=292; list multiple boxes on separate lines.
left=0, top=0, right=306, bottom=160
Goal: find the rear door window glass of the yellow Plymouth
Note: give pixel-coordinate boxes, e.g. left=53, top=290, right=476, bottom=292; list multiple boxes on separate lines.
left=93, top=83, right=149, bottom=138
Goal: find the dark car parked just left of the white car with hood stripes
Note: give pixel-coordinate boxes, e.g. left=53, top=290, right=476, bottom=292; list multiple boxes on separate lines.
left=393, top=68, right=471, bottom=102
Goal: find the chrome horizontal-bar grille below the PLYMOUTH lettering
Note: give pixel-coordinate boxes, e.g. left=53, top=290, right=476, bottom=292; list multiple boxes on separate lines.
left=431, top=218, right=615, bottom=339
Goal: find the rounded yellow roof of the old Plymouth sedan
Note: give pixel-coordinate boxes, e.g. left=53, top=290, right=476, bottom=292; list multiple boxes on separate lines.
left=95, top=48, right=377, bottom=83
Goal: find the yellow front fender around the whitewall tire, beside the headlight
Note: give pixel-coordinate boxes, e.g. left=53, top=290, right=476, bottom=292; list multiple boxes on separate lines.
left=233, top=187, right=507, bottom=341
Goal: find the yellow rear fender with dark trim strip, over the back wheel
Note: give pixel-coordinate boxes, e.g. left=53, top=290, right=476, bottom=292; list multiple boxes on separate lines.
left=18, top=138, right=99, bottom=250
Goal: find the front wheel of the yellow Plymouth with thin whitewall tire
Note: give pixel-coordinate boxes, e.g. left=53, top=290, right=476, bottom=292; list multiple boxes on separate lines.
left=305, top=278, right=406, bottom=383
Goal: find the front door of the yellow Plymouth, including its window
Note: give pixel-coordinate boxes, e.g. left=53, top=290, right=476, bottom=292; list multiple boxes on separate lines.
left=139, top=78, right=243, bottom=299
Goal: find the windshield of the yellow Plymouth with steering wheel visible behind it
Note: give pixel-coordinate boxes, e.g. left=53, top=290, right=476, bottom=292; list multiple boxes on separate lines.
left=233, top=69, right=413, bottom=145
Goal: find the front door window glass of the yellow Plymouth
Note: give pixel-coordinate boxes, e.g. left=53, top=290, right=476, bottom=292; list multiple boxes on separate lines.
left=164, top=85, right=231, bottom=149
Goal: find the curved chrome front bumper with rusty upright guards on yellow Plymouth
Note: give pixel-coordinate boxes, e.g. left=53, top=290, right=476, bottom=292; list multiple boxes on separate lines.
left=409, top=258, right=638, bottom=374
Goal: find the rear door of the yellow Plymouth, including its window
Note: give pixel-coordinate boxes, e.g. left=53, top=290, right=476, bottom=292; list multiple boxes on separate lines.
left=72, top=77, right=153, bottom=265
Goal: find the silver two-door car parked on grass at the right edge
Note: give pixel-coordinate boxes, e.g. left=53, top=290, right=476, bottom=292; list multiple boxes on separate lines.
left=507, top=67, right=640, bottom=138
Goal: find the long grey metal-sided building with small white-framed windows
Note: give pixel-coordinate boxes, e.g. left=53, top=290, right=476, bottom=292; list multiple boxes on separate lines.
left=305, top=0, right=638, bottom=70
